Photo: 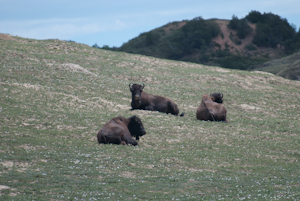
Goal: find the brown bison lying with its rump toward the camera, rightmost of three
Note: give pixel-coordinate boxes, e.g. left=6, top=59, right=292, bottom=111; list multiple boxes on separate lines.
left=196, top=93, right=227, bottom=122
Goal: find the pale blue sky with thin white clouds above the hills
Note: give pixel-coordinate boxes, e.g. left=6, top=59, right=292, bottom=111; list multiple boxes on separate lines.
left=0, top=0, right=300, bottom=47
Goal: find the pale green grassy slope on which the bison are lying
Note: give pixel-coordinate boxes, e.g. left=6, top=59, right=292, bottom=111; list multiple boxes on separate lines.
left=0, top=36, right=300, bottom=200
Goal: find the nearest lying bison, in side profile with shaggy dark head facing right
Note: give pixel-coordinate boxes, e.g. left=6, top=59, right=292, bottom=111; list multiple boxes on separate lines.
left=97, top=116, right=146, bottom=146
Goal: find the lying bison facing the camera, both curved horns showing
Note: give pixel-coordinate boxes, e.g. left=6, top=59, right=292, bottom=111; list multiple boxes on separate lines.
left=129, top=84, right=184, bottom=116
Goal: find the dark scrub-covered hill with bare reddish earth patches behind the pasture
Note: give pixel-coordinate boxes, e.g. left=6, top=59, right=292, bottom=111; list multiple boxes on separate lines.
left=103, top=11, right=300, bottom=79
